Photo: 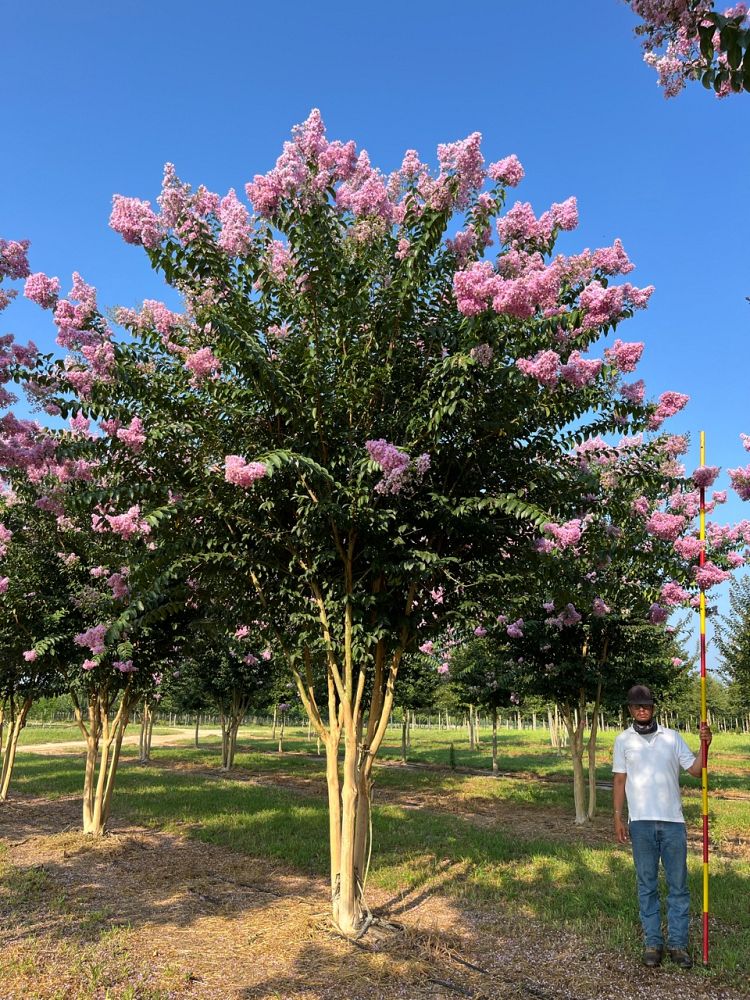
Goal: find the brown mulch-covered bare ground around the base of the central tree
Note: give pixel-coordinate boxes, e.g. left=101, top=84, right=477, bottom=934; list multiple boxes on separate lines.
left=0, top=784, right=750, bottom=1000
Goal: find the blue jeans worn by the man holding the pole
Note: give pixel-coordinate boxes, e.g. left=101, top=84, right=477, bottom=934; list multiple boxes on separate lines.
left=629, top=819, right=690, bottom=948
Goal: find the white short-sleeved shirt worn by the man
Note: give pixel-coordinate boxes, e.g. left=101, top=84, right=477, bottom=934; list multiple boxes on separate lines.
left=612, top=726, right=695, bottom=823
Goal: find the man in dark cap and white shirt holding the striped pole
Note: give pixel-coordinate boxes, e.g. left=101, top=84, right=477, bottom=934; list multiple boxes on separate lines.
left=612, top=684, right=711, bottom=969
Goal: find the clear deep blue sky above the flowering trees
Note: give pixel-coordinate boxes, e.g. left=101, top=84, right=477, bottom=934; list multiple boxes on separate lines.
left=0, top=0, right=750, bottom=672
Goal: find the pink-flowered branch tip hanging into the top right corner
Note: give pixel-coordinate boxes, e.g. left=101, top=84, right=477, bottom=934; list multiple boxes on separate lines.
left=627, top=0, right=750, bottom=97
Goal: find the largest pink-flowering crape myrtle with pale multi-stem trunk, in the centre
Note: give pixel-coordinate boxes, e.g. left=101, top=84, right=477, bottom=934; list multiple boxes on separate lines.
left=13, top=111, right=674, bottom=935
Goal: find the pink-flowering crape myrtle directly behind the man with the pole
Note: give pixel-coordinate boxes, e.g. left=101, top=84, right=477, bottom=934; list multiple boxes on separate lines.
left=482, top=436, right=750, bottom=823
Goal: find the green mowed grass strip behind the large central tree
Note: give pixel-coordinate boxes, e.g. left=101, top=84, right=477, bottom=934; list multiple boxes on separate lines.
left=14, top=730, right=750, bottom=981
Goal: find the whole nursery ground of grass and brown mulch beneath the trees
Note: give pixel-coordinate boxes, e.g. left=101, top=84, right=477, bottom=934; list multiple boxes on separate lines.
left=0, top=726, right=750, bottom=1000
